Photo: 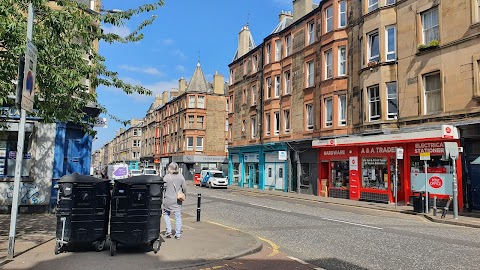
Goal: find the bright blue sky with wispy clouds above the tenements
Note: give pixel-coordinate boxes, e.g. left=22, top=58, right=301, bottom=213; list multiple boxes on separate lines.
left=93, top=0, right=294, bottom=150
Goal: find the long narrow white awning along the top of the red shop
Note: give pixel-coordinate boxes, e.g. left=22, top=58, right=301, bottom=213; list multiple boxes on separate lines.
left=312, top=125, right=460, bottom=148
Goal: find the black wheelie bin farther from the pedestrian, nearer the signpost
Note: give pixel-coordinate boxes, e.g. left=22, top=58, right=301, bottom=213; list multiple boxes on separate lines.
left=55, top=173, right=111, bottom=254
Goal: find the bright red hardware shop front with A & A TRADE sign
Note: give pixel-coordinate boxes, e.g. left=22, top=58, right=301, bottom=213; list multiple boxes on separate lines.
left=312, top=126, right=463, bottom=209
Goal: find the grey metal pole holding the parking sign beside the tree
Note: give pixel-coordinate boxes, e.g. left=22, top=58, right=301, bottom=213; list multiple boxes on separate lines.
left=7, top=3, right=34, bottom=260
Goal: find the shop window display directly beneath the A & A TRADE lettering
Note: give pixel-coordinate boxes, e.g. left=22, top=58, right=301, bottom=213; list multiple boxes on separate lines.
left=362, top=158, right=388, bottom=190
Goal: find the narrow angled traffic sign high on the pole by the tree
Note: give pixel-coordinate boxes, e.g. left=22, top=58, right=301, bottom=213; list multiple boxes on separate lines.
left=22, top=41, right=38, bottom=112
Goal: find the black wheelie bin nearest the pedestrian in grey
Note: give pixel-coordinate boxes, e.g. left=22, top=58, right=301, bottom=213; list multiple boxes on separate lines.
left=110, top=175, right=164, bottom=256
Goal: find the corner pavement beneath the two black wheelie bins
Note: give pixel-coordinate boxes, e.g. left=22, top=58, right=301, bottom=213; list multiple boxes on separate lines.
left=0, top=213, right=262, bottom=270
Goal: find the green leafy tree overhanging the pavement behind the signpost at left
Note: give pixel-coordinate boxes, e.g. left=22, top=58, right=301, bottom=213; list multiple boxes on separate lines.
left=0, top=0, right=164, bottom=130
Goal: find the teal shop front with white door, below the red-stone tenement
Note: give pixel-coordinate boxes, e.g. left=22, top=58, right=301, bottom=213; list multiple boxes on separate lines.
left=228, top=143, right=289, bottom=191
